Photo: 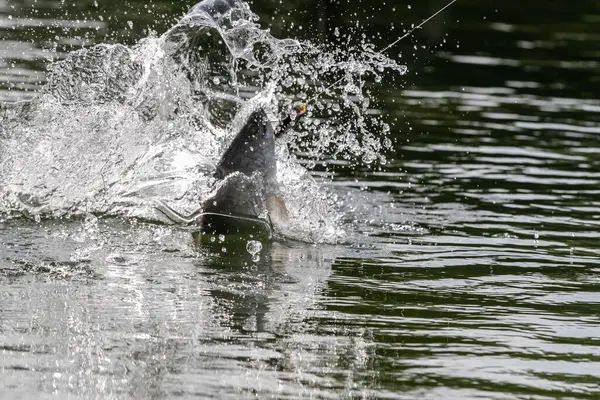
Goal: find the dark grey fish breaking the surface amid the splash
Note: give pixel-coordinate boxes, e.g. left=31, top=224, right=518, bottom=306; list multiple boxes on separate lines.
left=156, top=105, right=306, bottom=243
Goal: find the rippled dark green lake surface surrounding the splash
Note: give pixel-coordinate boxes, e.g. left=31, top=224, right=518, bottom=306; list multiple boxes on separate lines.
left=0, top=0, right=600, bottom=399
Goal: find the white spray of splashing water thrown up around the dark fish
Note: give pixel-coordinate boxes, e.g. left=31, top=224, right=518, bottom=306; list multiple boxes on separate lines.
left=0, top=0, right=405, bottom=242
